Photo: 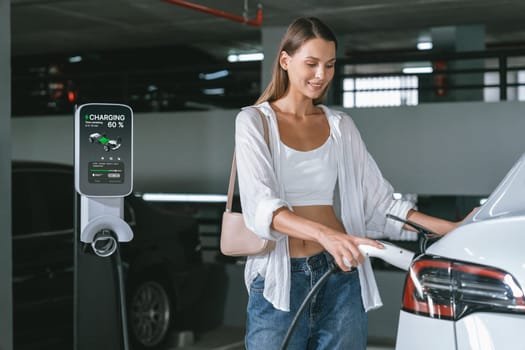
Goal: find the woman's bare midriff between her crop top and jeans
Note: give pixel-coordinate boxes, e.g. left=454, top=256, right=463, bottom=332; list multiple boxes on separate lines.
left=288, top=205, right=345, bottom=258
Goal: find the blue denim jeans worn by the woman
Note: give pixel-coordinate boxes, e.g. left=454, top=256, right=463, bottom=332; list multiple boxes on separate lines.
left=246, top=252, right=368, bottom=350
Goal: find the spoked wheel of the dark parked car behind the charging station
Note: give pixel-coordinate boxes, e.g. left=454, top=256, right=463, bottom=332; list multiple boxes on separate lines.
left=128, top=279, right=174, bottom=349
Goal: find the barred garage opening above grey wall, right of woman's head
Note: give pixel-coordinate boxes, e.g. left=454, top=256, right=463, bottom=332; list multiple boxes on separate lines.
left=330, top=48, right=525, bottom=107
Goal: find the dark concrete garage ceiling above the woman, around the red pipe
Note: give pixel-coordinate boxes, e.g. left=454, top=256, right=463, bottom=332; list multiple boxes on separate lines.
left=11, top=0, right=525, bottom=58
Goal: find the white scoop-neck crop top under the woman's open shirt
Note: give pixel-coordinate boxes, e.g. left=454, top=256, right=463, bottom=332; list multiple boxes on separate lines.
left=281, top=136, right=337, bottom=206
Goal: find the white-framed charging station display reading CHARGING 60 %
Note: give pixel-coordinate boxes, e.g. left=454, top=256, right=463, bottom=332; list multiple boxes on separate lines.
left=75, top=103, right=133, bottom=197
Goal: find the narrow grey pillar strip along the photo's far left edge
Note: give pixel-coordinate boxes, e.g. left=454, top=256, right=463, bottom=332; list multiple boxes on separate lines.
left=0, top=0, right=13, bottom=350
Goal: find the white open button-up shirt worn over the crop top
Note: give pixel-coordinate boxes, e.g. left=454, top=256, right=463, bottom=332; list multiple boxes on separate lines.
left=235, top=102, right=416, bottom=311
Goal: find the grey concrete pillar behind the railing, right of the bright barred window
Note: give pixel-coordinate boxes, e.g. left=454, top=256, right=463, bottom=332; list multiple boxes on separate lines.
left=419, top=25, right=485, bottom=102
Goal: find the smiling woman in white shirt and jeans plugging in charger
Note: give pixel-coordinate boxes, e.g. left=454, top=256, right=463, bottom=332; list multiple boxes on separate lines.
left=235, top=18, right=457, bottom=350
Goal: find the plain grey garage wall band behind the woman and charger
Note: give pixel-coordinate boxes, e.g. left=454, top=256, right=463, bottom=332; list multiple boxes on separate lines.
left=12, top=102, right=525, bottom=195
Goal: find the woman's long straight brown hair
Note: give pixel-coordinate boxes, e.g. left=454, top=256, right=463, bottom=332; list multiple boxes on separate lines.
left=255, top=17, right=337, bottom=104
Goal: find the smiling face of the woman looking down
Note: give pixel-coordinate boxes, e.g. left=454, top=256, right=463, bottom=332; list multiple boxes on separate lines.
left=279, top=38, right=336, bottom=99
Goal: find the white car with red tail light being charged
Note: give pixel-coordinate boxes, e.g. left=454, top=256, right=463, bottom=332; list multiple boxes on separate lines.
left=396, top=155, right=525, bottom=350
